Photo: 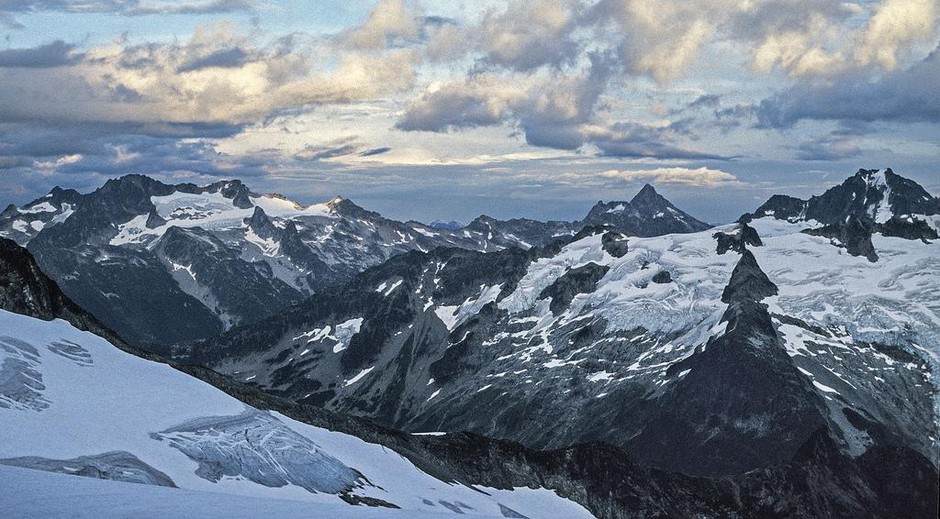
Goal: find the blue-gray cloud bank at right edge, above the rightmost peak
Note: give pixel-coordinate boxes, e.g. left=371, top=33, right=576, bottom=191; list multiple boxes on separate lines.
left=757, top=48, right=940, bottom=128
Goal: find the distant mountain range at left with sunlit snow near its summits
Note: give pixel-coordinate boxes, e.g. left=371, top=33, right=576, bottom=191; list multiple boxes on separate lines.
left=0, top=175, right=708, bottom=351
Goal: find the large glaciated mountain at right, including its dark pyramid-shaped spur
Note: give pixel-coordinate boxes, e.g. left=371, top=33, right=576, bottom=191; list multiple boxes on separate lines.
left=184, top=169, right=940, bottom=490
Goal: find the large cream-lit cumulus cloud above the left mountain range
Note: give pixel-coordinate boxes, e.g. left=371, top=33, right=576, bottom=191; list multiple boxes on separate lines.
left=0, top=20, right=418, bottom=125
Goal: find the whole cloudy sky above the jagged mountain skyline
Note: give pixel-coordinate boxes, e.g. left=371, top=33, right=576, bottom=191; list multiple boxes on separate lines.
left=0, top=0, right=940, bottom=223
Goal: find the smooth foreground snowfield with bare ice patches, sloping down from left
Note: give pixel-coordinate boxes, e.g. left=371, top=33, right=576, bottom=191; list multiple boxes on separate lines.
left=0, top=311, right=590, bottom=517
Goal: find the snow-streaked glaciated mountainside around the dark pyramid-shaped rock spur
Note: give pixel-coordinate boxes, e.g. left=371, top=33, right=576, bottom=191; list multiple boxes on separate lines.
left=192, top=191, right=940, bottom=468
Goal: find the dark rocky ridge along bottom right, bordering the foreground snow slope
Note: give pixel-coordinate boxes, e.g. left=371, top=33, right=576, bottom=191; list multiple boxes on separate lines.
left=183, top=367, right=938, bottom=519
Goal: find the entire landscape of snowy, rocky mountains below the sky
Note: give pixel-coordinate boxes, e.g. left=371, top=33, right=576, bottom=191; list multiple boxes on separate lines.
left=0, top=169, right=940, bottom=519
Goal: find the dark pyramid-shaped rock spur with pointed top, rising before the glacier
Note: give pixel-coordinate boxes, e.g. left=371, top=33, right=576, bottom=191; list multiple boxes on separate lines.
left=629, top=251, right=826, bottom=476
